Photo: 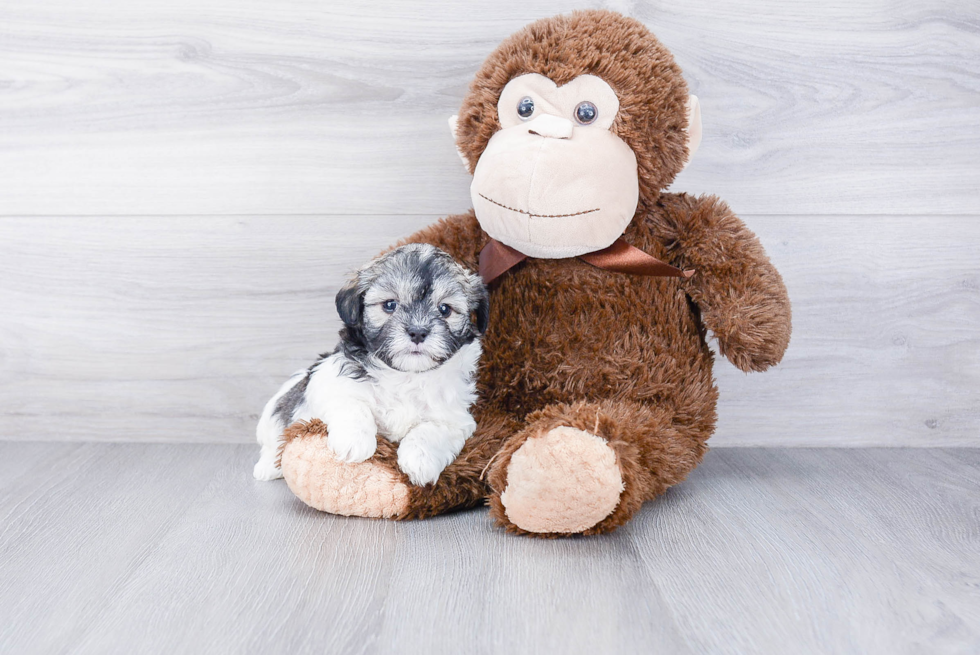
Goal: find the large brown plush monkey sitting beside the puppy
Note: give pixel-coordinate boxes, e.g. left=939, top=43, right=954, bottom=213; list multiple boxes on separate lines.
left=281, top=11, right=790, bottom=536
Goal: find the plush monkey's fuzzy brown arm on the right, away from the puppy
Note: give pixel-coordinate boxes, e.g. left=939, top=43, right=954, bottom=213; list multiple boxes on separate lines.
left=658, top=194, right=792, bottom=371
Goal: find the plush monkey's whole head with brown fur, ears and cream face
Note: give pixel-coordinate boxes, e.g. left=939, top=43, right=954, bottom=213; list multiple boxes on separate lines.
left=450, top=10, right=701, bottom=259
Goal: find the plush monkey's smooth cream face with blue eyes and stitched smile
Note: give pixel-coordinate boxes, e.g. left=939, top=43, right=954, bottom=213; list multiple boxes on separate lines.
left=470, top=73, right=639, bottom=258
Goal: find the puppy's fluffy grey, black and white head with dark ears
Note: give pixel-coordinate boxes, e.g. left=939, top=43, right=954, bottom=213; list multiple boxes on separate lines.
left=337, top=244, right=490, bottom=372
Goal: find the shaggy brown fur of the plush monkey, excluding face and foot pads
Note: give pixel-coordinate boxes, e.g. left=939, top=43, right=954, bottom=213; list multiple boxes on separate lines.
left=278, top=11, right=790, bottom=536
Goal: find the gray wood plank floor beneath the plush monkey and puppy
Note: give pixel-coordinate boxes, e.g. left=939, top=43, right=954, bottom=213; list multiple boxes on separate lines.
left=0, top=442, right=980, bottom=654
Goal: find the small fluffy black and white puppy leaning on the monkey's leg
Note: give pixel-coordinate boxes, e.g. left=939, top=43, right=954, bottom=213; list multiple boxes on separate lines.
left=253, top=244, right=489, bottom=485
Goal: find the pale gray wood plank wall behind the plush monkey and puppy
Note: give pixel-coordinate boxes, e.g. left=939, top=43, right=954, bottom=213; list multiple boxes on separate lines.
left=0, top=0, right=980, bottom=445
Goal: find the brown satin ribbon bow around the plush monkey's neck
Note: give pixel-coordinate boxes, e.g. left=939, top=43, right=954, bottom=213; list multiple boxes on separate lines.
left=480, top=237, right=694, bottom=284
